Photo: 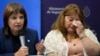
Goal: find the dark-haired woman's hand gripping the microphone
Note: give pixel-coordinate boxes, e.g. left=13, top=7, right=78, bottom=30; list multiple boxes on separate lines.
left=14, top=46, right=28, bottom=56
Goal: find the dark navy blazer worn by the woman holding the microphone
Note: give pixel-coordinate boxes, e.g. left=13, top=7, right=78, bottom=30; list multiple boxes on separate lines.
left=0, top=29, right=38, bottom=56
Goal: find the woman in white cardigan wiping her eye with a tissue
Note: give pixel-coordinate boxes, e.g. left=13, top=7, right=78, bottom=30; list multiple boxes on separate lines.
left=44, top=4, right=100, bottom=56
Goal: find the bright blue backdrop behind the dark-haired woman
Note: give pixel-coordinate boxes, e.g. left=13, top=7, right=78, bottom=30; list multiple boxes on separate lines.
left=0, top=0, right=41, bottom=40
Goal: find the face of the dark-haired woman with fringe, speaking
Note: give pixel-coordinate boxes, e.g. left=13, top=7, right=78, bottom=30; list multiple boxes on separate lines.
left=8, top=13, right=25, bottom=33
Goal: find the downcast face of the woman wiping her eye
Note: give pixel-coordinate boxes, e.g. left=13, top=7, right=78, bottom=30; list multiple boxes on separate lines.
left=64, top=15, right=80, bottom=33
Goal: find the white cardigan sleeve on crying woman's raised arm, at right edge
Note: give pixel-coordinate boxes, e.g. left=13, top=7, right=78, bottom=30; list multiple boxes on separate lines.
left=84, top=29, right=100, bottom=45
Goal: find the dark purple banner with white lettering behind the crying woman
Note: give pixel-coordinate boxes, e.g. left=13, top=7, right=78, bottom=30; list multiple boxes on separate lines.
left=41, top=0, right=100, bottom=41
